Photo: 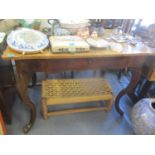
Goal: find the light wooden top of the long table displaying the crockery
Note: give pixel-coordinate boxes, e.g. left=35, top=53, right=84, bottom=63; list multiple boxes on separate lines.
left=2, top=28, right=155, bottom=60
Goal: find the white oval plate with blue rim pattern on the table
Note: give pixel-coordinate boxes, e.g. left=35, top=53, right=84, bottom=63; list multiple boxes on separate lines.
left=7, top=28, right=49, bottom=54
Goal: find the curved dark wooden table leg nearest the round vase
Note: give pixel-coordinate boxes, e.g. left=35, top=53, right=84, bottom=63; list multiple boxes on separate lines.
left=115, top=69, right=141, bottom=116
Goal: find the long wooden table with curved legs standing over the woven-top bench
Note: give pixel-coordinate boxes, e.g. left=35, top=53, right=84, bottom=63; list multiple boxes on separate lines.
left=2, top=45, right=155, bottom=133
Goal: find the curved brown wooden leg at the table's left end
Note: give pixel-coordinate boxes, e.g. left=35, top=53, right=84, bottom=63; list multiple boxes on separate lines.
left=17, top=73, right=36, bottom=133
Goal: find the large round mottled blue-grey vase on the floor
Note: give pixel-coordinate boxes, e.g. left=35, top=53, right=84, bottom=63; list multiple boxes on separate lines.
left=131, top=98, right=155, bottom=135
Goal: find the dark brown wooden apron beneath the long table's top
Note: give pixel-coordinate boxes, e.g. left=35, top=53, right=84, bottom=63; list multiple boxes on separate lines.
left=16, top=57, right=145, bottom=73
